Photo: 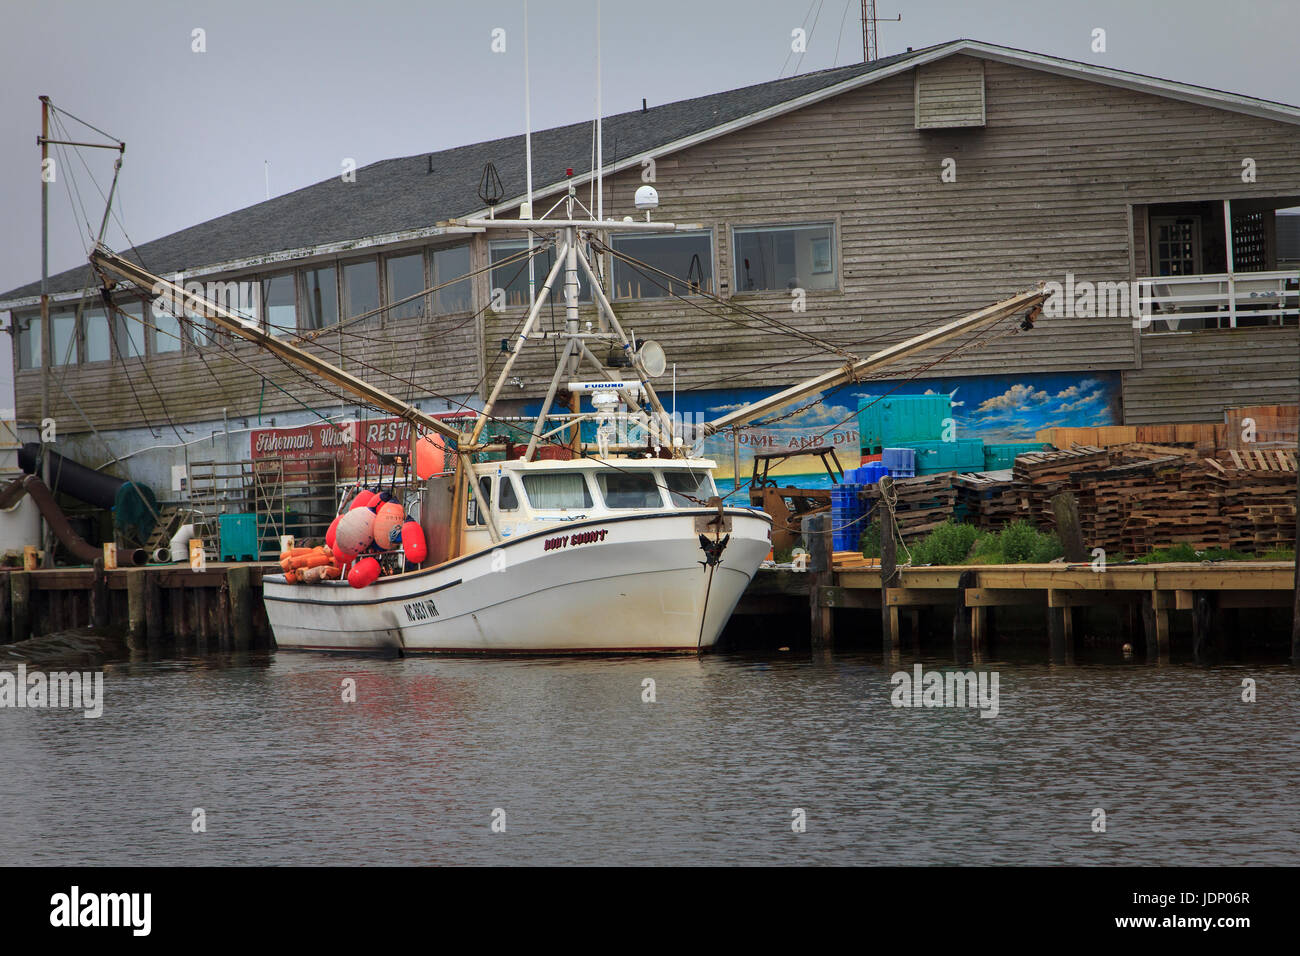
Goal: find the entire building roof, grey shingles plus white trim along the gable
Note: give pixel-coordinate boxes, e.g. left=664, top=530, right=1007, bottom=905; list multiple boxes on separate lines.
left=10, top=39, right=1300, bottom=308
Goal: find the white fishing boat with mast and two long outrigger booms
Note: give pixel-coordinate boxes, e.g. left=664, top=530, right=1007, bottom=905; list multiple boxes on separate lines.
left=91, top=231, right=1047, bottom=654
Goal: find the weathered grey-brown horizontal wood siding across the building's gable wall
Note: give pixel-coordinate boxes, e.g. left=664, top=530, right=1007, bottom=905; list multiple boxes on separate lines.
left=18, top=57, right=1300, bottom=428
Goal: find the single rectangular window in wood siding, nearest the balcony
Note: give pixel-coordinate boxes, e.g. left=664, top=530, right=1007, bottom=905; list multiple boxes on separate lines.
left=732, top=222, right=839, bottom=293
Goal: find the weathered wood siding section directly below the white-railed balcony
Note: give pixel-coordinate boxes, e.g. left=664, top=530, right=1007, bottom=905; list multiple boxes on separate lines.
left=1123, top=328, right=1300, bottom=425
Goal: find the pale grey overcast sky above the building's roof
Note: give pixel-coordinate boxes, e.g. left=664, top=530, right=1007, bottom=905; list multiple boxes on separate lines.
left=0, top=0, right=1300, bottom=300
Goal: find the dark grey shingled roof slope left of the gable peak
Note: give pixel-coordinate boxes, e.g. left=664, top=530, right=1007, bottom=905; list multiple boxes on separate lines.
left=0, top=41, right=920, bottom=300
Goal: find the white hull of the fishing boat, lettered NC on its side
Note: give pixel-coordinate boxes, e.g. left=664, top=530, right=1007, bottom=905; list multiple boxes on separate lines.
left=263, top=509, right=771, bottom=654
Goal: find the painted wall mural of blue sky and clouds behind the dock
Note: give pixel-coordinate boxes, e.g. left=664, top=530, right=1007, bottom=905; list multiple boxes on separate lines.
left=676, top=372, right=1121, bottom=493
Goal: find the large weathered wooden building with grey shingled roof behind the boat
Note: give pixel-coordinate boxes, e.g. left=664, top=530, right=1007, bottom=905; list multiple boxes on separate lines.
left=0, top=40, right=1300, bottom=502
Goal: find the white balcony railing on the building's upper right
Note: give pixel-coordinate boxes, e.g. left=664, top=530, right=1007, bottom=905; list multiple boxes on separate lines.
left=1138, top=269, right=1300, bottom=332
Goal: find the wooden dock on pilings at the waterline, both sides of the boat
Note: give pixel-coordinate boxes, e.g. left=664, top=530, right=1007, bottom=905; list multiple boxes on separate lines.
left=0, top=553, right=1294, bottom=661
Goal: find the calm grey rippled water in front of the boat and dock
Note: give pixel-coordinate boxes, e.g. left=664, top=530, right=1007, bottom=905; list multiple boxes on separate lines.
left=0, top=653, right=1300, bottom=865
